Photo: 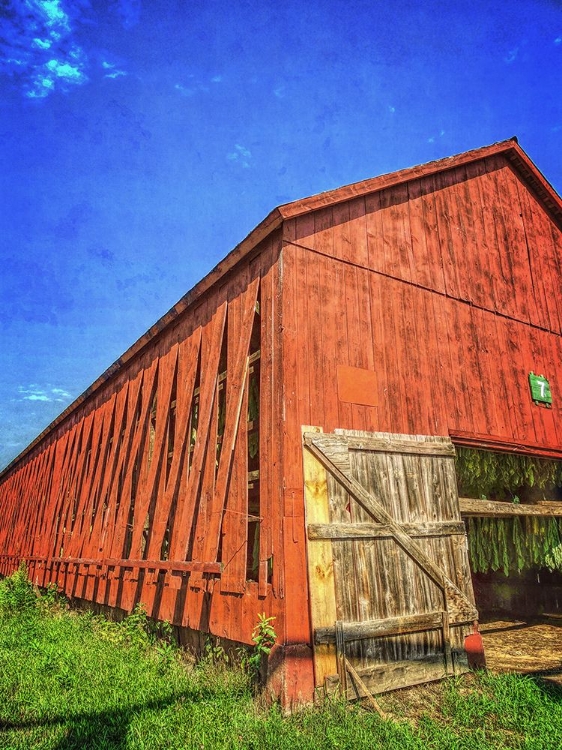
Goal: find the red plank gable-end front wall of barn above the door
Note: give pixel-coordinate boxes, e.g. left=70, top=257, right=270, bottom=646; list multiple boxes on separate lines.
left=283, top=151, right=562, bottom=656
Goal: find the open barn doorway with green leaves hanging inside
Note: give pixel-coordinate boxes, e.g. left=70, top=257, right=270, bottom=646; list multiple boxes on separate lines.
left=456, top=447, right=562, bottom=672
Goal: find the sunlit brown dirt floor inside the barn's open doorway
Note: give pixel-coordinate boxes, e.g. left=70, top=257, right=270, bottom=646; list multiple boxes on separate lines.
left=474, top=615, right=562, bottom=684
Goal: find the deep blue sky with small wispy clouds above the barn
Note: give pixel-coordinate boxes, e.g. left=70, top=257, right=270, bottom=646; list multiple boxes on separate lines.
left=0, top=0, right=562, bottom=466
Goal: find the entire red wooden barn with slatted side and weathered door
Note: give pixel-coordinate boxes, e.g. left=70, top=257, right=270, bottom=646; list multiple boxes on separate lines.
left=0, top=139, right=562, bottom=703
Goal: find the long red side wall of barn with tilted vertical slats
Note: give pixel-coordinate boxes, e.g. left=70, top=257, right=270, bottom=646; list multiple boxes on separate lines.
left=0, top=233, right=284, bottom=643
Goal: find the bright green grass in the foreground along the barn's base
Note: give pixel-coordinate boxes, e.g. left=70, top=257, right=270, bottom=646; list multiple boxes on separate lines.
left=0, top=576, right=562, bottom=750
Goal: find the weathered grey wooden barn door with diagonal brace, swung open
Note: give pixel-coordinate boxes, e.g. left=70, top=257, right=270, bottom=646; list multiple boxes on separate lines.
left=303, top=428, right=478, bottom=698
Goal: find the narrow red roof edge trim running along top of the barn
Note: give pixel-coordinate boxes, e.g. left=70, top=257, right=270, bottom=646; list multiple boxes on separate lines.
left=0, top=137, right=562, bottom=477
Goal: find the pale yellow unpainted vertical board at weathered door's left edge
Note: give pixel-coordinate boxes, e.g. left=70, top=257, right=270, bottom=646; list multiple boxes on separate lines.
left=302, top=426, right=338, bottom=687
